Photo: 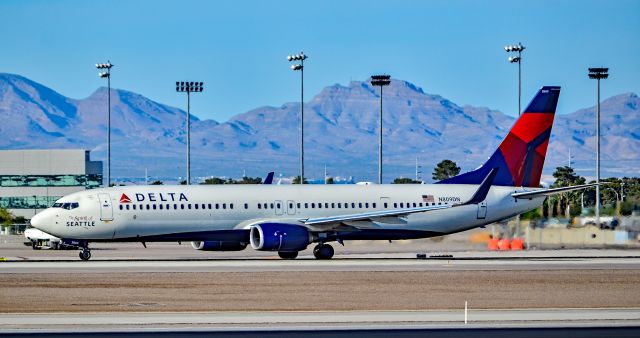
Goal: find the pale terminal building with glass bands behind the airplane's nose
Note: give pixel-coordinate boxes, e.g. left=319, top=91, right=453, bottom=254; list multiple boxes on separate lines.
left=0, top=149, right=102, bottom=219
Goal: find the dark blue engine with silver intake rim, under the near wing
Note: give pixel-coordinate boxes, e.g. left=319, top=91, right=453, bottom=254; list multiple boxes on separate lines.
left=249, top=223, right=313, bottom=251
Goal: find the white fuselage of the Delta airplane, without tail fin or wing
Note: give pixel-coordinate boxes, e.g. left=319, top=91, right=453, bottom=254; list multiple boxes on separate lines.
left=32, top=184, right=544, bottom=241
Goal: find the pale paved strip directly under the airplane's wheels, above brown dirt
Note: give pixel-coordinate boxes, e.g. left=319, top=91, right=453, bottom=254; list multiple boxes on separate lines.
left=0, top=256, right=640, bottom=274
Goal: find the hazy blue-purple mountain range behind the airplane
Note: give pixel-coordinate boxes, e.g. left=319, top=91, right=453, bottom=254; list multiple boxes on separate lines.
left=0, top=73, right=640, bottom=182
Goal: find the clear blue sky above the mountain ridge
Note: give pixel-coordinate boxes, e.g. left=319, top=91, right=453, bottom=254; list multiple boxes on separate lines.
left=0, top=0, right=640, bottom=121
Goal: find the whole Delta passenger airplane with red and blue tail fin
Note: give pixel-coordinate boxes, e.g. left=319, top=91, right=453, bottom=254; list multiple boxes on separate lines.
left=31, top=86, right=595, bottom=260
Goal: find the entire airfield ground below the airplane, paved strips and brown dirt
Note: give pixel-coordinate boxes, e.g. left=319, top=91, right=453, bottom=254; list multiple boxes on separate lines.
left=0, top=236, right=640, bottom=337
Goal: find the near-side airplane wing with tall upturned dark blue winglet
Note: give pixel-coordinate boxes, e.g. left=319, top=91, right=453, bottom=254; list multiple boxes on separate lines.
left=301, top=168, right=498, bottom=225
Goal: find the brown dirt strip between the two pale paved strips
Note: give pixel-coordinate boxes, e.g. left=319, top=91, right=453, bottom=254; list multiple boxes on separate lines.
left=0, top=269, right=640, bottom=313
